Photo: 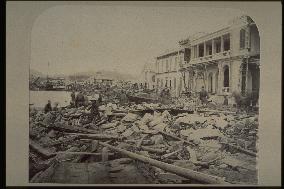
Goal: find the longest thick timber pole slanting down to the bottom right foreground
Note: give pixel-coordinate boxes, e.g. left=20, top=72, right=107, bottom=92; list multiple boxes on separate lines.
left=100, top=142, right=229, bottom=184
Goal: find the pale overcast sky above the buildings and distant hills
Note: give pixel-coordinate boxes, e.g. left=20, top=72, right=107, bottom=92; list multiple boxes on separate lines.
left=31, top=5, right=242, bottom=75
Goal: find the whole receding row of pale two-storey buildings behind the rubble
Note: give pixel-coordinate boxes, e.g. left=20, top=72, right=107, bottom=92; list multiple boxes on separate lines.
left=140, top=16, right=260, bottom=102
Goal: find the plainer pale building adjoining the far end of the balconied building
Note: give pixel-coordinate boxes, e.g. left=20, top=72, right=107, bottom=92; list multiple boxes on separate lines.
left=155, top=49, right=184, bottom=97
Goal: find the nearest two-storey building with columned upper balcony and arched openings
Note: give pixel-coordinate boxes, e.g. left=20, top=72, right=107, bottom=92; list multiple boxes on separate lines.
left=179, top=16, right=260, bottom=102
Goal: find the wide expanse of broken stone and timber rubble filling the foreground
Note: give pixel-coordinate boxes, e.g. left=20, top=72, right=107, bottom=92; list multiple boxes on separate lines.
left=29, top=102, right=258, bottom=184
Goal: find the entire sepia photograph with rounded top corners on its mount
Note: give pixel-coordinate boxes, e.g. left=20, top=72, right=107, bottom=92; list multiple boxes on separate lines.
left=6, top=2, right=282, bottom=186
